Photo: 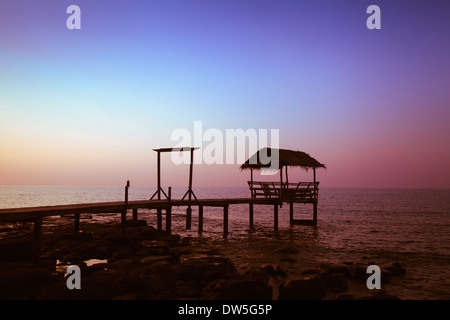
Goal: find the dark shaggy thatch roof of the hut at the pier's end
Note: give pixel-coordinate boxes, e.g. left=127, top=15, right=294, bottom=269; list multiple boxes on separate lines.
left=240, top=148, right=326, bottom=170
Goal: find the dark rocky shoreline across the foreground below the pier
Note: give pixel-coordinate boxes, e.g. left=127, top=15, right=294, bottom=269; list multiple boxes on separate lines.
left=0, top=221, right=405, bottom=300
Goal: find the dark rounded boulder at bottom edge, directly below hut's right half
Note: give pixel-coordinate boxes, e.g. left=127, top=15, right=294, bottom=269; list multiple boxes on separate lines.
left=278, top=275, right=325, bottom=300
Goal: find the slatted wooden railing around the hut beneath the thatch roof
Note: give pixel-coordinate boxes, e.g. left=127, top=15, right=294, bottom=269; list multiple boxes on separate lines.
left=248, top=181, right=319, bottom=201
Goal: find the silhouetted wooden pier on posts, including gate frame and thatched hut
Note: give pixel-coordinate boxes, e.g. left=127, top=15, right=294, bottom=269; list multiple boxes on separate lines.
left=0, top=147, right=325, bottom=255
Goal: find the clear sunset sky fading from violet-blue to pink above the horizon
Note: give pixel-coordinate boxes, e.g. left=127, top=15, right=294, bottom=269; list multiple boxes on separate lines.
left=0, top=0, right=450, bottom=188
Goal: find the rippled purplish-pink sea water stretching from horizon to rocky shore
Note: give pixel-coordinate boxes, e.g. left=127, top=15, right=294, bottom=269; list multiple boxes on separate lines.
left=0, top=186, right=450, bottom=299
